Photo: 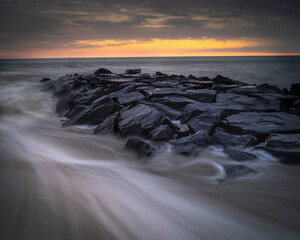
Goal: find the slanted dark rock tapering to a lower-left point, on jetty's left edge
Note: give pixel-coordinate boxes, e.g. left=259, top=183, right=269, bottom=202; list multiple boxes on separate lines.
left=63, top=96, right=122, bottom=127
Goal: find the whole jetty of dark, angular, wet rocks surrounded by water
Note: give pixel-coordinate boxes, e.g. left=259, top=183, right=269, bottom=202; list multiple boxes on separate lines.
left=41, top=68, right=300, bottom=170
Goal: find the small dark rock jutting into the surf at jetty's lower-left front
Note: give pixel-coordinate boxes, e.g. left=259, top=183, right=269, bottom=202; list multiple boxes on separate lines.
left=125, top=138, right=159, bottom=158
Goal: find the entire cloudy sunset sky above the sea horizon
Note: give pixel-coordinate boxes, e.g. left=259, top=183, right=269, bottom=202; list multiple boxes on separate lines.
left=0, top=0, right=300, bottom=58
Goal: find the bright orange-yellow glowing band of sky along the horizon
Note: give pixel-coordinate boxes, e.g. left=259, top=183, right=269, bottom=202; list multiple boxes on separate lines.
left=0, top=38, right=300, bottom=58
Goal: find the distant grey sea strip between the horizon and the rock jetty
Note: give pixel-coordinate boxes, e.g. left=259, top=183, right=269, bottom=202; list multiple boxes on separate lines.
left=0, top=56, right=300, bottom=89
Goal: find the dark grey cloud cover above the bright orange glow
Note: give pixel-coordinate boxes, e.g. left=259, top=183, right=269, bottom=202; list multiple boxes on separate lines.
left=0, top=0, right=300, bottom=55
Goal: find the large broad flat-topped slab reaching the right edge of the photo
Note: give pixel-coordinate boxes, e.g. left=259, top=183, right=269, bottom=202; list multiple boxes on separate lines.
left=222, top=112, right=300, bottom=140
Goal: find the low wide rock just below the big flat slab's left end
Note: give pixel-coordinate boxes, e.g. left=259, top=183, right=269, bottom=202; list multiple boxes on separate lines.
left=211, top=132, right=257, bottom=148
